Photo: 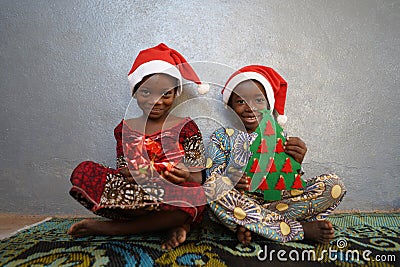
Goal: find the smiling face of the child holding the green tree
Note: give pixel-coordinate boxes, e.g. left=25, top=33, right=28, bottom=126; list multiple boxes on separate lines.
left=229, top=80, right=270, bottom=132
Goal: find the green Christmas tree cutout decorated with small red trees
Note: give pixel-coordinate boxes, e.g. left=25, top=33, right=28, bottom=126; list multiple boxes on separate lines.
left=245, top=110, right=305, bottom=201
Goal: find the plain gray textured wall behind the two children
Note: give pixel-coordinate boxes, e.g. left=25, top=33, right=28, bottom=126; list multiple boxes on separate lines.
left=0, top=0, right=400, bottom=214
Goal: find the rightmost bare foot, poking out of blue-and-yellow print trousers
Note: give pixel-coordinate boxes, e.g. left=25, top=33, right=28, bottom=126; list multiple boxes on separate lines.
left=301, top=221, right=335, bottom=244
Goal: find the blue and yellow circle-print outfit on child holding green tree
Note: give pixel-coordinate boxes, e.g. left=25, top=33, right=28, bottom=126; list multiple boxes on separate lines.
left=204, top=128, right=346, bottom=242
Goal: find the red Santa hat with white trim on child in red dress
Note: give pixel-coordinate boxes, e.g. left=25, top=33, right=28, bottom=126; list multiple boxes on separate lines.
left=128, top=43, right=209, bottom=96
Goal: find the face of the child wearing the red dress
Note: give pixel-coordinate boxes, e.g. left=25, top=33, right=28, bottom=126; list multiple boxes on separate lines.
left=134, top=73, right=177, bottom=120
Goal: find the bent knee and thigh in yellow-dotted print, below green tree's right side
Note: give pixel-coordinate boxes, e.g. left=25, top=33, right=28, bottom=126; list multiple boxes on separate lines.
left=263, top=174, right=346, bottom=221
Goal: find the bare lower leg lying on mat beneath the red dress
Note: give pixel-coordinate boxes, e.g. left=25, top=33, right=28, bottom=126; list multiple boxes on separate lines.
left=68, top=210, right=190, bottom=237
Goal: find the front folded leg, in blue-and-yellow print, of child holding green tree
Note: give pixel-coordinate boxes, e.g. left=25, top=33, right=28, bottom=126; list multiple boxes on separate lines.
left=210, top=189, right=334, bottom=244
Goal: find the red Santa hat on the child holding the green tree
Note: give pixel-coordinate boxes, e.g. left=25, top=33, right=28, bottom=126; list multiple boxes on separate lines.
left=222, top=65, right=287, bottom=125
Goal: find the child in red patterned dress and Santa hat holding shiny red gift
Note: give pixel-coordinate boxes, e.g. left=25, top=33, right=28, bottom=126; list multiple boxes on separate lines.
left=68, top=44, right=206, bottom=249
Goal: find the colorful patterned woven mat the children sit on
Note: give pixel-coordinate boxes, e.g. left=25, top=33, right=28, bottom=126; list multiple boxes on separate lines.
left=0, top=213, right=400, bottom=267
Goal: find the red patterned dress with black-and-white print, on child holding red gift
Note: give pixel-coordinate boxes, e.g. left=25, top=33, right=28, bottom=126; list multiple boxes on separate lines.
left=69, top=118, right=206, bottom=222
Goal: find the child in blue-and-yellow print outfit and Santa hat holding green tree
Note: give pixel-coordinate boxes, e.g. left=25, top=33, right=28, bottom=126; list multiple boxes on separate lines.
left=204, top=65, right=346, bottom=244
